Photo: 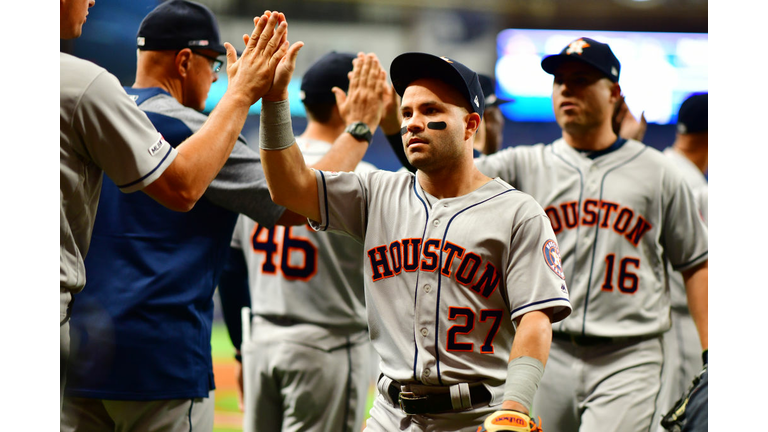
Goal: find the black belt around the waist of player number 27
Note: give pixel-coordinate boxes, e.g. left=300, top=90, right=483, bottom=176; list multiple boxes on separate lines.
left=387, top=381, right=491, bottom=414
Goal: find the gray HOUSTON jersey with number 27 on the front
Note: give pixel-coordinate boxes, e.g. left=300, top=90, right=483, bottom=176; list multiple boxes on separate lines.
left=311, top=171, right=571, bottom=403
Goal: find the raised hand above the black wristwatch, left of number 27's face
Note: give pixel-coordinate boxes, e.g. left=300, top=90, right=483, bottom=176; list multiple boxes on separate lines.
left=333, top=53, right=388, bottom=132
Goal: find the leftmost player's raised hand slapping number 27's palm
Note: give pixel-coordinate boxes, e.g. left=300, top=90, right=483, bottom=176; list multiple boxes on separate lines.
left=224, top=11, right=289, bottom=106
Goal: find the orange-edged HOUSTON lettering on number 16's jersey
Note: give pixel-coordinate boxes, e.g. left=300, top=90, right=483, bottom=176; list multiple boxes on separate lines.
left=544, top=199, right=652, bottom=247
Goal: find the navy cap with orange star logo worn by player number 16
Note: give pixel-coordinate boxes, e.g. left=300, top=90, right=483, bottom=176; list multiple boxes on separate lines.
left=541, top=38, right=621, bottom=82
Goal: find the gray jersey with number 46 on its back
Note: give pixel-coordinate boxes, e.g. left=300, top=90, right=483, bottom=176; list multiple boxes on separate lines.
left=232, top=138, right=375, bottom=331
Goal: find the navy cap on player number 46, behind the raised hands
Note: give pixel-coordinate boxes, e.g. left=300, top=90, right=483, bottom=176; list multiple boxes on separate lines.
left=301, top=51, right=357, bottom=104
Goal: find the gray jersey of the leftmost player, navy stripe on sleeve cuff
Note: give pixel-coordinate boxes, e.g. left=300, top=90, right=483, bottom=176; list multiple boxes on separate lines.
left=59, top=53, right=177, bottom=292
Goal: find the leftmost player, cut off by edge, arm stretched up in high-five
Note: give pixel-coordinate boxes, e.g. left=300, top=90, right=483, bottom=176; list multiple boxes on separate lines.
left=59, top=0, right=294, bottom=412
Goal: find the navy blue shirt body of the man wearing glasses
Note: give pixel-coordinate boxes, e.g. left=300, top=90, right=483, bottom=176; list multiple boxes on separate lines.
left=66, top=88, right=282, bottom=400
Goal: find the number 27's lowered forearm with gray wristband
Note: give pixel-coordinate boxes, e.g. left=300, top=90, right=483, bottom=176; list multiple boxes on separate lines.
left=502, top=311, right=552, bottom=414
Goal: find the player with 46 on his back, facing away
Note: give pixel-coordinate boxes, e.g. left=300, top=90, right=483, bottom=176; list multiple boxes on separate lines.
left=219, top=52, right=390, bottom=432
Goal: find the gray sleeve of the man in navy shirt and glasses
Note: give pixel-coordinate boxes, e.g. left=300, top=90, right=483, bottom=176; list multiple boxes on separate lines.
left=205, top=137, right=285, bottom=228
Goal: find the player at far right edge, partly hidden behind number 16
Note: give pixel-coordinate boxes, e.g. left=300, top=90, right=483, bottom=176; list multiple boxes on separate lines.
left=656, top=93, right=709, bottom=431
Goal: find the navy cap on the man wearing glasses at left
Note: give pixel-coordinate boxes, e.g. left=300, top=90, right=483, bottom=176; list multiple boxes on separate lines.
left=136, top=0, right=227, bottom=54
